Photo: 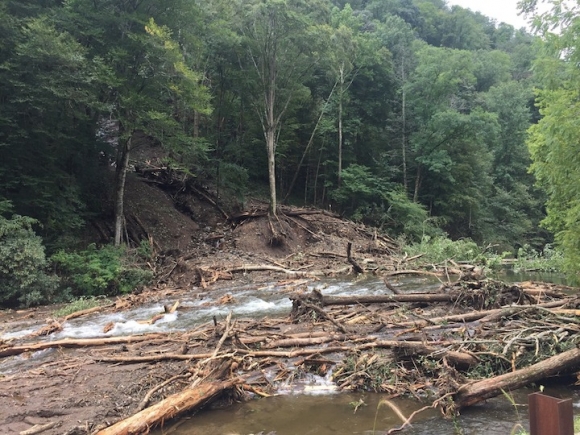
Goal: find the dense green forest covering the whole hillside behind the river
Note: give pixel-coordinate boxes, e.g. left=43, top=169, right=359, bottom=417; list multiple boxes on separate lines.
left=0, top=0, right=580, bottom=305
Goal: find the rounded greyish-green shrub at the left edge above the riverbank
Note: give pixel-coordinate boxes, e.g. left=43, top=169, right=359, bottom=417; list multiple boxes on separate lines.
left=0, top=215, right=58, bottom=306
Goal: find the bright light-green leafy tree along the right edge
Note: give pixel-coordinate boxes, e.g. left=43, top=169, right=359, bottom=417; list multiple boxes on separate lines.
left=522, top=1, right=580, bottom=276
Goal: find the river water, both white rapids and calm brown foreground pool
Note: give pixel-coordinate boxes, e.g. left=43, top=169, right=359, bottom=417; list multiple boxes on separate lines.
left=0, top=274, right=580, bottom=435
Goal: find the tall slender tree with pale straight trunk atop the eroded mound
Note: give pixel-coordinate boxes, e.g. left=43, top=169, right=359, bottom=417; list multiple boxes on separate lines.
left=238, top=0, right=320, bottom=216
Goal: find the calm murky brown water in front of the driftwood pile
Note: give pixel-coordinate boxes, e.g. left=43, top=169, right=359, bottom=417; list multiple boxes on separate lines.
left=152, top=390, right=565, bottom=435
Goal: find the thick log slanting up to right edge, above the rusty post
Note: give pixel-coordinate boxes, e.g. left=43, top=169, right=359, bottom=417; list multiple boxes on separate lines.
left=454, top=348, right=580, bottom=408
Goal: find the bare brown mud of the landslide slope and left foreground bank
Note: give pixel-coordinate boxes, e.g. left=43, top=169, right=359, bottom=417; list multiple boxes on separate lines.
left=0, top=169, right=396, bottom=435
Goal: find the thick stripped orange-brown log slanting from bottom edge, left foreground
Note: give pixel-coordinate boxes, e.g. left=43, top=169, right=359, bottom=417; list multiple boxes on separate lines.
left=96, top=380, right=236, bottom=435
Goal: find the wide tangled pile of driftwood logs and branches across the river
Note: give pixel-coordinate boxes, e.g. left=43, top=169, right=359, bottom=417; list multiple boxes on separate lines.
left=0, top=277, right=580, bottom=435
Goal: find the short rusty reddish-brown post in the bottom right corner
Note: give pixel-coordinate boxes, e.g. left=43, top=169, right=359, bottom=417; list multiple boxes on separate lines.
left=528, top=393, right=574, bottom=435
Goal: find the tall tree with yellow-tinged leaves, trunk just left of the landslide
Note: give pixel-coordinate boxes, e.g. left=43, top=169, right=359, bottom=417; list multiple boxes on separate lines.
left=63, top=0, right=209, bottom=245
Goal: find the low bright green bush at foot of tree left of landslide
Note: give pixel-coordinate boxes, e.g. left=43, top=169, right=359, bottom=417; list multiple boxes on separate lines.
left=51, top=244, right=152, bottom=296
